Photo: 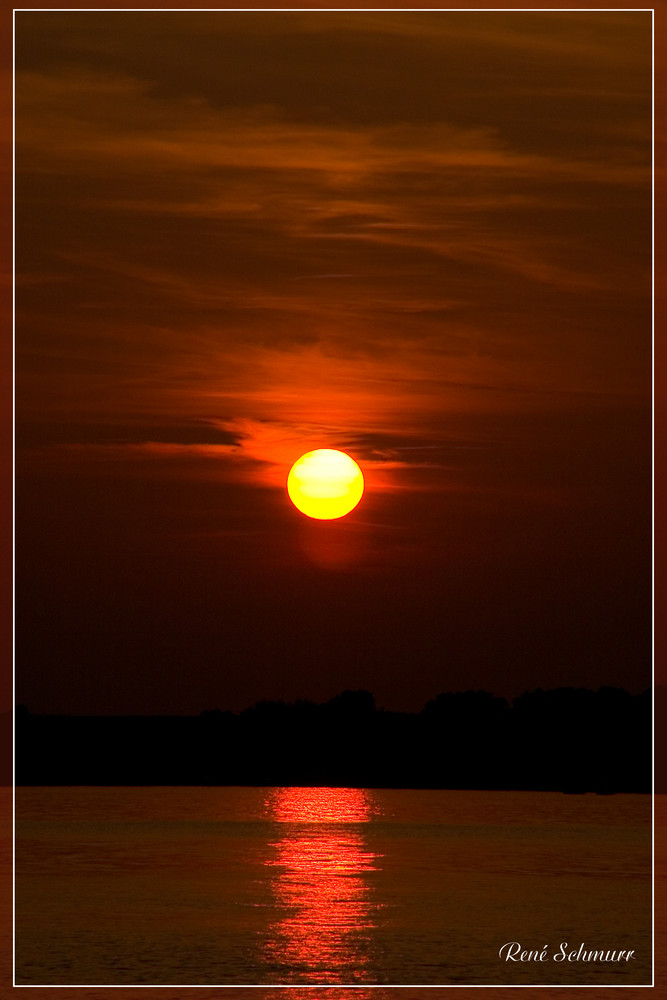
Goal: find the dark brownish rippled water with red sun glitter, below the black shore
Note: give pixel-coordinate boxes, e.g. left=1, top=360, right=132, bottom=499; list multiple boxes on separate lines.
left=16, top=788, right=651, bottom=996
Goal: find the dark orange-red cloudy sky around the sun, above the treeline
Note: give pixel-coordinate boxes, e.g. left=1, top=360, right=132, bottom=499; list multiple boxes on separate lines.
left=15, top=10, right=651, bottom=714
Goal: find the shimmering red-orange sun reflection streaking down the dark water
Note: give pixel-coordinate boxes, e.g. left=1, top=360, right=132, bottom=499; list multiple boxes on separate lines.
left=264, top=788, right=380, bottom=984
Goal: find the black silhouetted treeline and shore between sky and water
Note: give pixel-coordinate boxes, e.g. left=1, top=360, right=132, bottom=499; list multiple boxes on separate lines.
left=15, top=687, right=651, bottom=794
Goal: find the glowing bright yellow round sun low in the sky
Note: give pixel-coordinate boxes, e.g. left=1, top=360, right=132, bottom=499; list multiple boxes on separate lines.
left=287, top=448, right=364, bottom=521
